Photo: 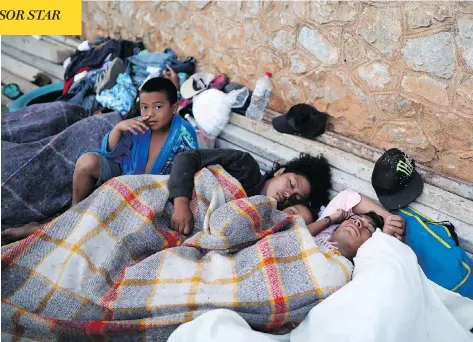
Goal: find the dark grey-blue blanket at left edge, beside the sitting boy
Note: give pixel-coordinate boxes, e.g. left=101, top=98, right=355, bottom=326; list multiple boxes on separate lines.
left=2, top=102, right=121, bottom=230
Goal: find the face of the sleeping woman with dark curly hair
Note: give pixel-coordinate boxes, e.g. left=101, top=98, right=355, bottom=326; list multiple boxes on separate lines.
left=262, top=169, right=310, bottom=203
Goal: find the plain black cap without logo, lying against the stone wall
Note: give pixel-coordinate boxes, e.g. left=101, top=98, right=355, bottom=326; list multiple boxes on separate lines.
left=272, top=103, right=327, bottom=139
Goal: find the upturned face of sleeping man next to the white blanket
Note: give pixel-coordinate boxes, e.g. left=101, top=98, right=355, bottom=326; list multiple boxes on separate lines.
left=333, top=215, right=376, bottom=259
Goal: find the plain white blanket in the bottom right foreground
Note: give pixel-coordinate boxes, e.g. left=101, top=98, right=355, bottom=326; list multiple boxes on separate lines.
left=168, top=231, right=473, bottom=342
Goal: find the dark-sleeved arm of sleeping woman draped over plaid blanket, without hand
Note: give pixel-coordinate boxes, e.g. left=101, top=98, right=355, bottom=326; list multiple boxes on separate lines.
left=168, top=148, right=261, bottom=199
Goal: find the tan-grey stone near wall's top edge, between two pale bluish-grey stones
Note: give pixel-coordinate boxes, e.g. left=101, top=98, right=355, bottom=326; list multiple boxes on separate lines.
left=357, top=7, right=402, bottom=57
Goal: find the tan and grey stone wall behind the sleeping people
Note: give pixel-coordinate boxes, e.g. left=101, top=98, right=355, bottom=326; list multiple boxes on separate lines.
left=83, top=1, right=473, bottom=181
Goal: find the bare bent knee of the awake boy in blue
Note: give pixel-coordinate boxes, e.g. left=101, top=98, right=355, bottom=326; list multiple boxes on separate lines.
left=72, top=153, right=100, bottom=206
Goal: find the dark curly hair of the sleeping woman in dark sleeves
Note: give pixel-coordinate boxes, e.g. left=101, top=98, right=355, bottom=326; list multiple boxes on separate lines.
left=267, top=153, right=332, bottom=212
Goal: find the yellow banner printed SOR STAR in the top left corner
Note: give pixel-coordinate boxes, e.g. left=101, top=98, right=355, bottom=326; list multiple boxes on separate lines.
left=0, top=0, right=82, bottom=35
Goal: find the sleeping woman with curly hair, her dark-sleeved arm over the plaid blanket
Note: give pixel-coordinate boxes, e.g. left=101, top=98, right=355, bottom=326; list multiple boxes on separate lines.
left=168, top=148, right=331, bottom=235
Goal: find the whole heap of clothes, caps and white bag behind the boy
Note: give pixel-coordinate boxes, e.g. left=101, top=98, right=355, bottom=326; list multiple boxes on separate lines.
left=59, top=38, right=262, bottom=143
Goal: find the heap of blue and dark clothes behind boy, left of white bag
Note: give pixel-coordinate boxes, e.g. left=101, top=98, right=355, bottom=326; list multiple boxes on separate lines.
left=58, top=38, right=195, bottom=117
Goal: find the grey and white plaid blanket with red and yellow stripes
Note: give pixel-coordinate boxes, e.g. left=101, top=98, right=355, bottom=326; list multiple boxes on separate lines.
left=1, top=166, right=352, bottom=341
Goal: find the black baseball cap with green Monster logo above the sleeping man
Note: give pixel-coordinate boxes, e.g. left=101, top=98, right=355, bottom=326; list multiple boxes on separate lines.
left=371, top=148, right=424, bottom=210
